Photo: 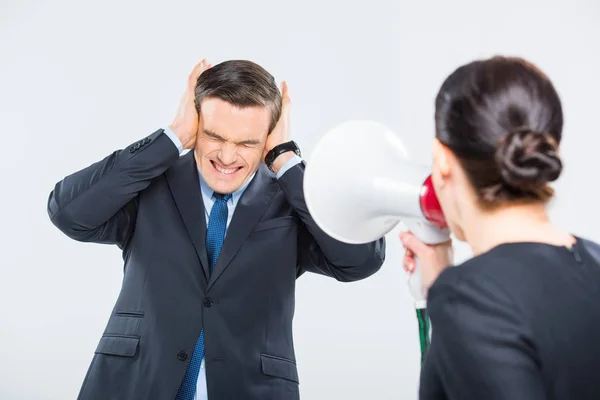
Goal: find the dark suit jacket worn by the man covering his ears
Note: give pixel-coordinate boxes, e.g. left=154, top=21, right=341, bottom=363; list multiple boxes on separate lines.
left=48, top=130, right=385, bottom=400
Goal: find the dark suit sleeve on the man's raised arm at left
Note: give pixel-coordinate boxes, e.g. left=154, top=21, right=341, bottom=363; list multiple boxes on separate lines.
left=48, top=129, right=179, bottom=248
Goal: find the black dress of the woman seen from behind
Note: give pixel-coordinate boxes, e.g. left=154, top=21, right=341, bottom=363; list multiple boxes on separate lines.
left=419, top=238, right=600, bottom=400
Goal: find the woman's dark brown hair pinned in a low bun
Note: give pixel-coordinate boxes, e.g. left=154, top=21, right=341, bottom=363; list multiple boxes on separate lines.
left=435, top=57, right=563, bottom=208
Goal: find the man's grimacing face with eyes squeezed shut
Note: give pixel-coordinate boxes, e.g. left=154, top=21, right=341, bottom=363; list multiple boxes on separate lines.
left=194, top=97, right=271, bottom=194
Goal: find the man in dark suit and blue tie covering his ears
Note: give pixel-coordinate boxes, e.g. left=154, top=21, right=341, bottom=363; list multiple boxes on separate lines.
left=48, top=61, right=385, bottom=400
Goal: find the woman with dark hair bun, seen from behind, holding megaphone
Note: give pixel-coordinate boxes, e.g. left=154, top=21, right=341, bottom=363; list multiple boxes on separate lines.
left=400, top=57, right=600, bottom=400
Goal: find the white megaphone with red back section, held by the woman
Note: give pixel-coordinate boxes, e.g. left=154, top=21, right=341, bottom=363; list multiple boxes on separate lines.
left=304, top=121, right=450, bottom=309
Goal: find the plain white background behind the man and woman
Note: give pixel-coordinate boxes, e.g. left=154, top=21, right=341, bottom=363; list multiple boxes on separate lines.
left=0, top=0, right=600, bottom=400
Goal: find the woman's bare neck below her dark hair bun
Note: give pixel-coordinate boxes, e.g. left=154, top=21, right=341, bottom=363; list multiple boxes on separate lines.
left=462, top=204, right=575, bottom=255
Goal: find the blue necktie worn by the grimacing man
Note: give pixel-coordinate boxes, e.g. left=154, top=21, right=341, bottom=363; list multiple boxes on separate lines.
left=175, top=193, right=231, bottom=400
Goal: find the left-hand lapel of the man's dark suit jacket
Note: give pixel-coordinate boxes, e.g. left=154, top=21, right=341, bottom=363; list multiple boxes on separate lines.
left=166, top=151, right=209, bottom=281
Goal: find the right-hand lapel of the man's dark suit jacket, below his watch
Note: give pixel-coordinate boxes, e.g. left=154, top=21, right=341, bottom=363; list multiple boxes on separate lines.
left=207, top=164, right=279, bottom=290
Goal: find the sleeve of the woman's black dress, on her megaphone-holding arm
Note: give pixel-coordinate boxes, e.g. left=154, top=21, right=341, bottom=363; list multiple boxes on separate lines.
left=421, top=275, right=546, bottom=400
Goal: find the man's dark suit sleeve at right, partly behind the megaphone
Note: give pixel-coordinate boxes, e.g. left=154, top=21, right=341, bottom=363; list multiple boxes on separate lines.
left=279, top=162, right=385, bottom=282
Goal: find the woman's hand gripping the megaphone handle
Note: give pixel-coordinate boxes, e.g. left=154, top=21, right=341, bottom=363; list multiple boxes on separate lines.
left=400, top=232, right=454, bottom=293
